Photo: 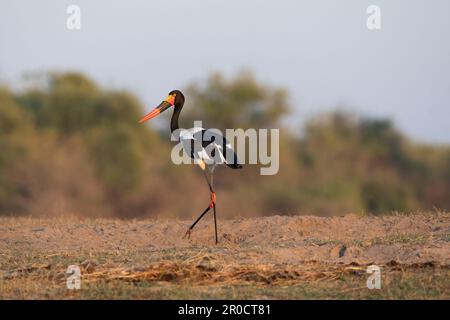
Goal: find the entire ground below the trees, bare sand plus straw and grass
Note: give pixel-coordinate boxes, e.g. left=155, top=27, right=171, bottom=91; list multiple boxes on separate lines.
left=0, top=213, right=450, bottom=299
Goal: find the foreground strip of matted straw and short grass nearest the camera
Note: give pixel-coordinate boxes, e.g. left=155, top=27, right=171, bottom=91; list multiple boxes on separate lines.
left=0, top=258, right=450, bottom=299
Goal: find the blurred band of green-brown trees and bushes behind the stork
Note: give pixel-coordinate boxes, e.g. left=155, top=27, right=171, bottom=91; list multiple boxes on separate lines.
left=0, top=71, right=450, bottom=217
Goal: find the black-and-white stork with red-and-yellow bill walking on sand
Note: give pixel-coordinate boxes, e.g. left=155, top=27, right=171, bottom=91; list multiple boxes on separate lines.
left=139, top=90, right=242, bottom=244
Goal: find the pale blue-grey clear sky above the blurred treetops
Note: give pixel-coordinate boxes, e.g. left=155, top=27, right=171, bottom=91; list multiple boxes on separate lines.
left=0, top=0, right=450, bottom=143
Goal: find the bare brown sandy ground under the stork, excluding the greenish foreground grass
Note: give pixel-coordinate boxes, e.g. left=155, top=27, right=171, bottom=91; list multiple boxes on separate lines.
left=0, top=212, right=450, bottom=298
